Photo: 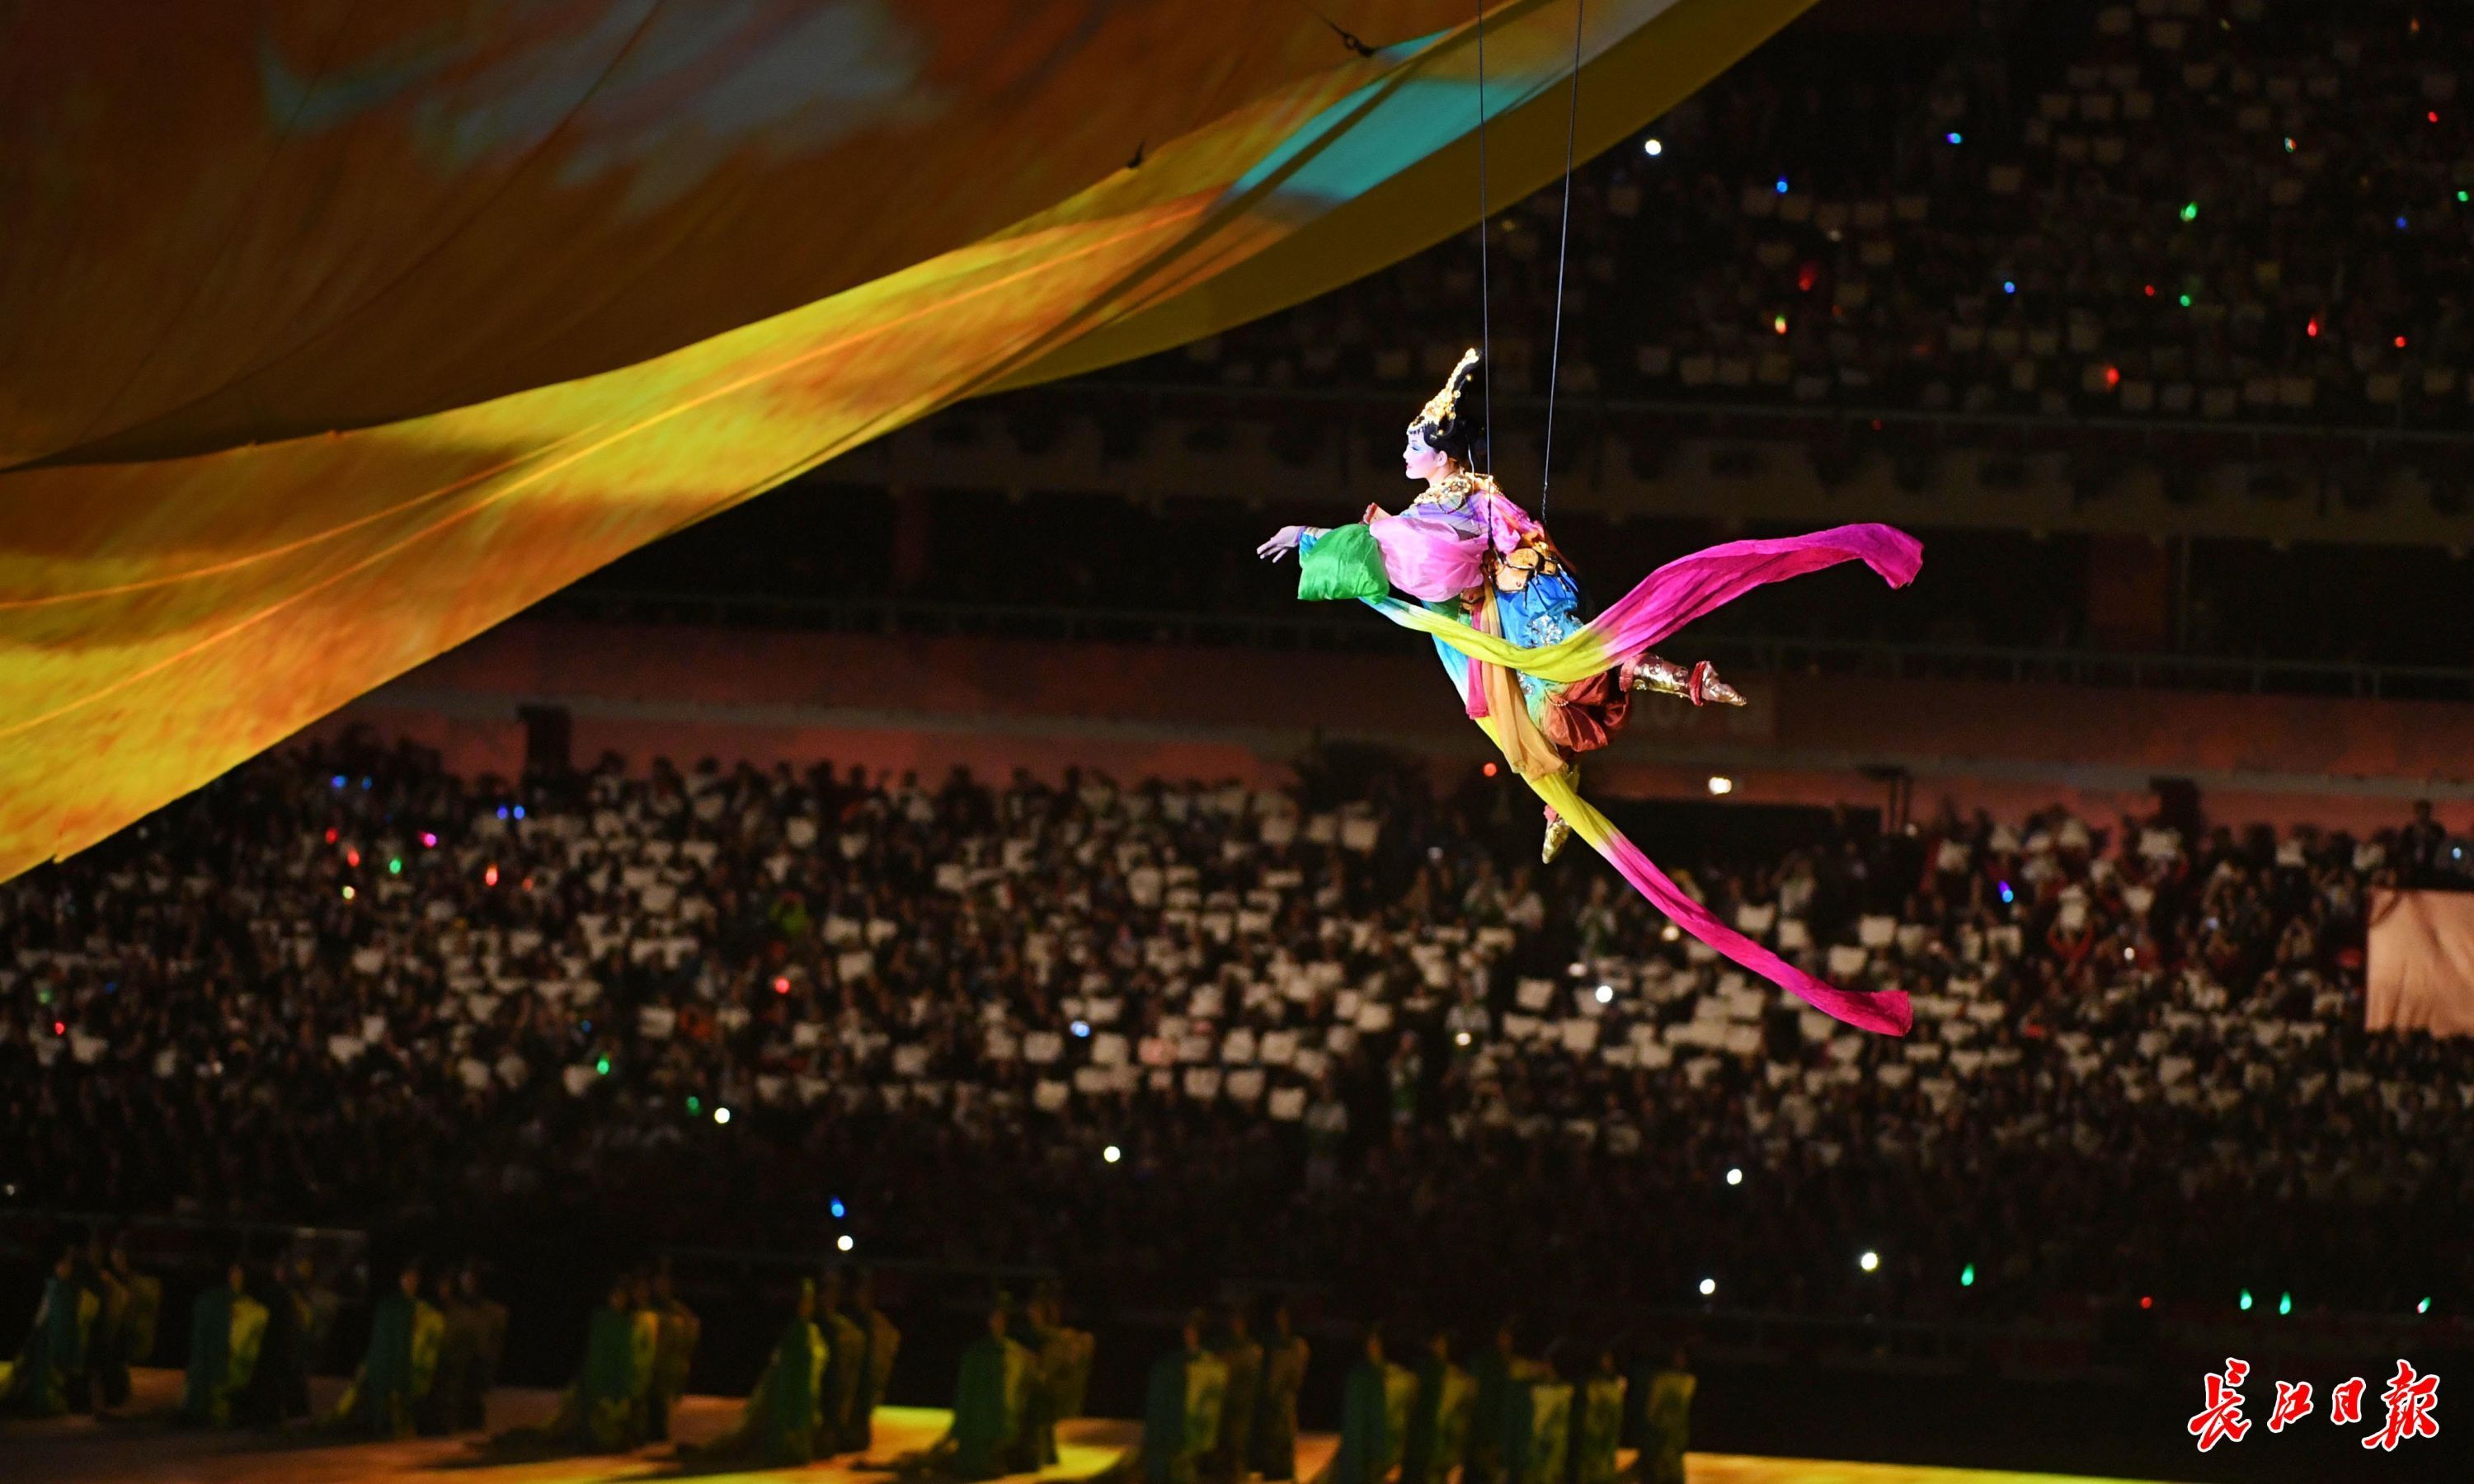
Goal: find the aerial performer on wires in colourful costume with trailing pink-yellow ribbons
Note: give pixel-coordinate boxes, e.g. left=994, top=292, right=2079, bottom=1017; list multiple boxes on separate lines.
left=1257, top=351, right=1925, bottom=1034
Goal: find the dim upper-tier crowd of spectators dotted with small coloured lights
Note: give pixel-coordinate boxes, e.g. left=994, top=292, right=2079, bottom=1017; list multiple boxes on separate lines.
left=1153, top=0, right=2474, bottom=428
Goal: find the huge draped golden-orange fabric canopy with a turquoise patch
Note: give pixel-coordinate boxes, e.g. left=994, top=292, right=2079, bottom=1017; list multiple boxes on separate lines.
left=0, top=0, right=1811, bottom=878
